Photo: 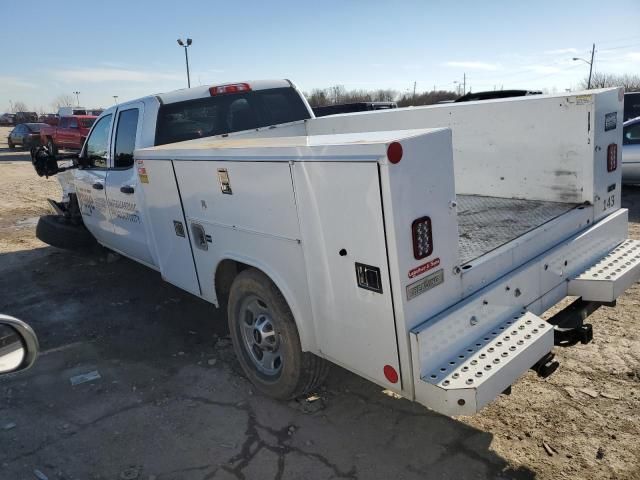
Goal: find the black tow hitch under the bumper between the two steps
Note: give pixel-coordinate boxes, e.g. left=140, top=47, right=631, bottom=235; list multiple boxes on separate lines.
left=548, top=298, right=616, bottom=347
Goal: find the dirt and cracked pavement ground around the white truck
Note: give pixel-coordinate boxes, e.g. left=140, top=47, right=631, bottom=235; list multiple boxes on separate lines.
left=0, top=124, right=640, bottom=480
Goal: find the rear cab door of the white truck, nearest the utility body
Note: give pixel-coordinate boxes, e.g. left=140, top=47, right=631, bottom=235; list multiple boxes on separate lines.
left=106, top=102, right=157, bottom=266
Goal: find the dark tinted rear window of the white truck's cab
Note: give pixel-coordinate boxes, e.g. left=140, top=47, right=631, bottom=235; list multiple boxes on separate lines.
left=155, top=87, right=310, bottom=145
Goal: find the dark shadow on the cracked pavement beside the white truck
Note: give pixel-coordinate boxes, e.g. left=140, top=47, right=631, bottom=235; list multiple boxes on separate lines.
left=0, top=247, right=535, bottom=479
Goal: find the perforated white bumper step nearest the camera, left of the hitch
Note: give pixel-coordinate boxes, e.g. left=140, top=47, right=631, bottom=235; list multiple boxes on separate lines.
left=417, top=312, right=557, bottom=415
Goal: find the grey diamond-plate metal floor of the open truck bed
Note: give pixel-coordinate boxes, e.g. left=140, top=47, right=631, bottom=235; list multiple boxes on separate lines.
left=456, top=195, right=578, bottom=264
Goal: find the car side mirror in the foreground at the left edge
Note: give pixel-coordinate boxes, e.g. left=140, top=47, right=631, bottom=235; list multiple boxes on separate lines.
left=0, top=314, right=39, bottom=375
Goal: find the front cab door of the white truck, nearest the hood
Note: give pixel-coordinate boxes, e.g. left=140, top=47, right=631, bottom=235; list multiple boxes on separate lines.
left=73, top=114, right=113, bottom=244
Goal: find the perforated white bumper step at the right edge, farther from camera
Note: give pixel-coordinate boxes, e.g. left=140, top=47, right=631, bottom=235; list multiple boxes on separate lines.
left=569, top=240, right=640, bottom=302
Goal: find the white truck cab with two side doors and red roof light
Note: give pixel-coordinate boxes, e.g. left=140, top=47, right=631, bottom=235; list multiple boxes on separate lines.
left=62, top=80, right=313, bottom=268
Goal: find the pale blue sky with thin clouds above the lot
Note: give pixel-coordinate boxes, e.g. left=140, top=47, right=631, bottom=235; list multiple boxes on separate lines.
left=0, top=0, right=640, bottom=112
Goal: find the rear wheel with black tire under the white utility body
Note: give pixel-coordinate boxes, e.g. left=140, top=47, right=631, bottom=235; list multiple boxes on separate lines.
left=228, top=268, right=330, bottom=400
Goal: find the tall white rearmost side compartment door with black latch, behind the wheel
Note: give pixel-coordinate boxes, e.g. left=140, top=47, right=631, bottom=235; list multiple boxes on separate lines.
left=292, top=162, right=401, bottom=391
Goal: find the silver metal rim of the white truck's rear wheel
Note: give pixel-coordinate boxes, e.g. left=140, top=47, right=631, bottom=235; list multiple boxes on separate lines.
left=239, top=295, right=283, bottom=376
